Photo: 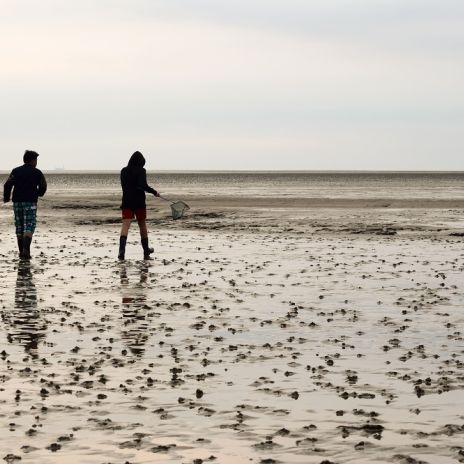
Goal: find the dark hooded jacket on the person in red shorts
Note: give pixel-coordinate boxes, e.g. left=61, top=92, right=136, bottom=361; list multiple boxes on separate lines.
left=121, top=153, right=157, bottom=209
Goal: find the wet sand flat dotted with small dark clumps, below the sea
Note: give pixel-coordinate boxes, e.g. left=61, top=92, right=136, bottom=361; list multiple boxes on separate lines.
left=0, top=195, right=464, bottom=464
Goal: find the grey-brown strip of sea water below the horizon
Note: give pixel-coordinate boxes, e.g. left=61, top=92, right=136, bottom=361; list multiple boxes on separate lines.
left=4, top=171, right=464, bottom=199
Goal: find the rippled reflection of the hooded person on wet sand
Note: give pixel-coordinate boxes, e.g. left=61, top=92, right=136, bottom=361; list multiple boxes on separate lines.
left=119, top=262, right=150, bottom=356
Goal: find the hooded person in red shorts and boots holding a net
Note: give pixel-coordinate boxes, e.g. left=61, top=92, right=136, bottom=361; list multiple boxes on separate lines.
left=118, top=151, right=159, bottom=260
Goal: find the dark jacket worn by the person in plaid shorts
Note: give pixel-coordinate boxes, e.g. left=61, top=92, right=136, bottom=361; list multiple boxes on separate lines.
left=3, top=164, right=47, bottom=203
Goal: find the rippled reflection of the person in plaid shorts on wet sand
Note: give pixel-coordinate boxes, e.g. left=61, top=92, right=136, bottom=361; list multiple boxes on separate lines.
left=2, top=261, right=46, bottom=358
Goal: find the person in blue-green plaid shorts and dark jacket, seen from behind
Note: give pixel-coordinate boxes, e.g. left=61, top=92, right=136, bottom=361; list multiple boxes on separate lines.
left=3, top=150, right=47, bottom=259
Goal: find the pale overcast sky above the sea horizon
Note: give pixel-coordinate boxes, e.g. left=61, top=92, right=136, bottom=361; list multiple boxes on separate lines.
left=0, top=0, right=464, bottom=170
